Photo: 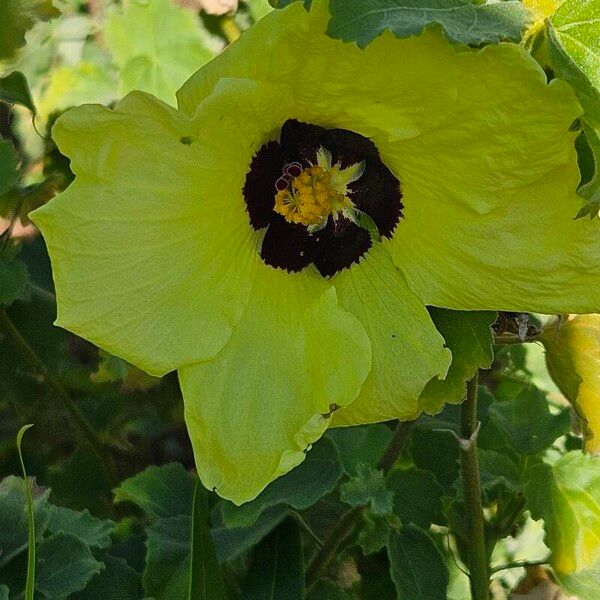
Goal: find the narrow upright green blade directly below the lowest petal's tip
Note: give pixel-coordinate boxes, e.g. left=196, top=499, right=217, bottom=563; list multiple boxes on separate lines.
left=188, top=480, right=227, bottom=600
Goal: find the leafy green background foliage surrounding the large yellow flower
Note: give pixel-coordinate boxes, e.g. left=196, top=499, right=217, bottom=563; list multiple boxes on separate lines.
left=0, top=0, right=600, bottom=600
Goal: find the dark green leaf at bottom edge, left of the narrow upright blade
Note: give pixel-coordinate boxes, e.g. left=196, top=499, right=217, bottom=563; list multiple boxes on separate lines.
left=69, top=556, right=142, bottom=600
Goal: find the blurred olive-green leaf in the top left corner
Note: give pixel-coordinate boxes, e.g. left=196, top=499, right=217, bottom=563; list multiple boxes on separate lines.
left=0, top=0, right=60, bottom=60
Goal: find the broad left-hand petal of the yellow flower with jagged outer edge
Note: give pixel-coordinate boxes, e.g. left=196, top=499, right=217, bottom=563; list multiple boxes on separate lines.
left=32, top=90, right=290, bottom=375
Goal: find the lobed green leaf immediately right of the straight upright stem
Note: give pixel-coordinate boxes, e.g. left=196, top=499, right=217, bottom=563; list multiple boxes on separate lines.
left=481, top=383, right=570, bottom=455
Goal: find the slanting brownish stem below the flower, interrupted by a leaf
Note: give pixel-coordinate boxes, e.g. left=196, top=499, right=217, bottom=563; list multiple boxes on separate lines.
left=306, top=421, right=414, bottom=589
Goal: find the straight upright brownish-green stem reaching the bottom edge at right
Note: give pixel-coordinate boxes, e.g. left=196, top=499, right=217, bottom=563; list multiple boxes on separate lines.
left=460, top=373, right=490, bottom=600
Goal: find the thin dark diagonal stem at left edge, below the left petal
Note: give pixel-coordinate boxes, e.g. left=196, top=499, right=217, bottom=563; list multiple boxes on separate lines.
left=0, top=308, right=118, bottom=487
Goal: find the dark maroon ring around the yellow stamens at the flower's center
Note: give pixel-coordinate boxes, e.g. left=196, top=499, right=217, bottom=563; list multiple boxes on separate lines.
left=243, top=119, right=403, bottom=277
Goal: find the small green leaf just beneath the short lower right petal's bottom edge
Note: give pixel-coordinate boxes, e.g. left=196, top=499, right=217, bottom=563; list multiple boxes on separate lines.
left=327, top=423, right=392, bottom=475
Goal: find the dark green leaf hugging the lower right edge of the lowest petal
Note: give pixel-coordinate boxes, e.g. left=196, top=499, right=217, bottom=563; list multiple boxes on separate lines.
left=222, top=438, right=343, bottom=527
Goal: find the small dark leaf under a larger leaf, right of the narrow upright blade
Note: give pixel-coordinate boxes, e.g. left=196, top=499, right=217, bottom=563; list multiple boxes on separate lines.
left=211, top=505, right=288, bottom=562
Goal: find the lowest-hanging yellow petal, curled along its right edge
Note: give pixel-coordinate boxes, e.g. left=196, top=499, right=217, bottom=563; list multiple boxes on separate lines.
left=179, top=265, right=371, bottom=503
